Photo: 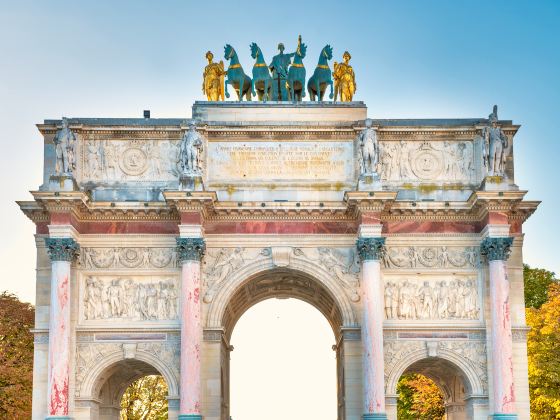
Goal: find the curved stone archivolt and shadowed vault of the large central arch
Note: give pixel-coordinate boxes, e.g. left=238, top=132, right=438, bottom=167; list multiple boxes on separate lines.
left=206, top=257, right=358, bottom=340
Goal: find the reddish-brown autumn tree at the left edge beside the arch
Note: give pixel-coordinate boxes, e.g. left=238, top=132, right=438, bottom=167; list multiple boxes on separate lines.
left=0, top=292, right=35, bottom=419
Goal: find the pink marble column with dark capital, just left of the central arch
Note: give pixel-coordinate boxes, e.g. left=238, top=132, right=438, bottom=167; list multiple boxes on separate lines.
left=177, top=238, right=205, bottom=420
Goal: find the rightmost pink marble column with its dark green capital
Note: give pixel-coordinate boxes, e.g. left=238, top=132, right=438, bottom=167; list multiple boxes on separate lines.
left=481, top=237, right=517, bottom=419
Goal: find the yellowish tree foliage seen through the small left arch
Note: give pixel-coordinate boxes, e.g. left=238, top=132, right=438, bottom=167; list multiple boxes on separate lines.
left=121, top=375, right=168, bottom=420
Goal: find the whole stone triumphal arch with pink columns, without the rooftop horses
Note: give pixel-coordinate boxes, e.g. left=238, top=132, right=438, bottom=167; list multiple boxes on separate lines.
left=19, top=92, right=538, bottom=420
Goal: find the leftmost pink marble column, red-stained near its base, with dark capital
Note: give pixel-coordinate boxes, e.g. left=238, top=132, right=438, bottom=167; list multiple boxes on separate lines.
left=46, top=238, right=79, bottom=419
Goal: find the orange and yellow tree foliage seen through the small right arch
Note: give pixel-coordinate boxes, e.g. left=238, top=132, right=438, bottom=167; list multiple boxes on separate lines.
left=397, top=373, right=445, bottom=420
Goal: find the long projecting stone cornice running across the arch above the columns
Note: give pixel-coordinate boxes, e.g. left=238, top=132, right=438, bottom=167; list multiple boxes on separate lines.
left=18, top=191, right=540, bottom=223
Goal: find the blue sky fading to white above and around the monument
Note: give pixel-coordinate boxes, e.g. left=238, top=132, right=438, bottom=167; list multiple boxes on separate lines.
left=0, top=0, right=560, bottom=302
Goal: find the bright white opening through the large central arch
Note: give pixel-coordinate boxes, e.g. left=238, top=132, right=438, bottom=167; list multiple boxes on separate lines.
left=230, top=298, right=338, bottom=420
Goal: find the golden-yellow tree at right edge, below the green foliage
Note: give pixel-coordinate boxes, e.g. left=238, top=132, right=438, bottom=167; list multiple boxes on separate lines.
left=527, top=282, right=560, bottom=420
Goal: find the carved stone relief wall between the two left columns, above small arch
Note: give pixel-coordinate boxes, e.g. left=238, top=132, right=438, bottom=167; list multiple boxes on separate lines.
left=79, top=246, right=180, bottom=324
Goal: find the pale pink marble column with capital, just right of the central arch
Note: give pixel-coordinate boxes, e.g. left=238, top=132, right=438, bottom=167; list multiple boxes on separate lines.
left=357, top=238, right=387, bottom=420
